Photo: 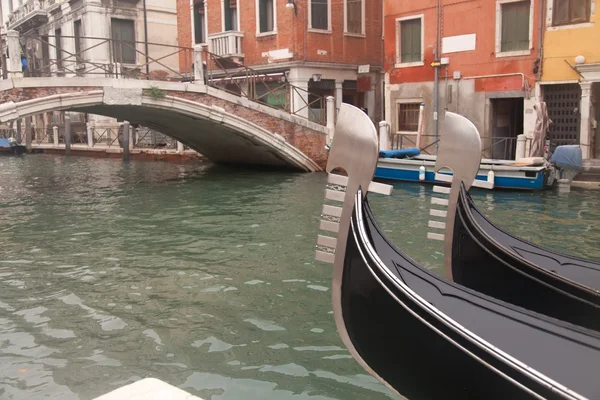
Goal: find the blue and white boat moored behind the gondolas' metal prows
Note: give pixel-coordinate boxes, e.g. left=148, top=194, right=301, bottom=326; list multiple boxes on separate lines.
left=375, top=155, right=555, bottom=190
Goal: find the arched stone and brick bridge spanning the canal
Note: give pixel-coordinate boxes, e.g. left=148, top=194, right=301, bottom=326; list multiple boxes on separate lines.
left=0, top=77, right=331, bottom=171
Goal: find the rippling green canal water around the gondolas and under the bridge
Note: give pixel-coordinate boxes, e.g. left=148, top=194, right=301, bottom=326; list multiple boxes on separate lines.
left=0, top=155, right=600, bottom=400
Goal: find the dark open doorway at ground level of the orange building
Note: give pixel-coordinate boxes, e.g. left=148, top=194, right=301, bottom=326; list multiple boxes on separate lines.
left=485, top=97, right=524, bottom=160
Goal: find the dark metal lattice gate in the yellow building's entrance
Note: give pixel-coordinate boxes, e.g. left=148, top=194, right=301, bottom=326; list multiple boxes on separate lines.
left=544, top=83, right=581, bottom=149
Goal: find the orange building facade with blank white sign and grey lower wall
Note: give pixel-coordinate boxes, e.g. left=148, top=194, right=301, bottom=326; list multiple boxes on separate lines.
left=384, top=0, right=543, bottom=159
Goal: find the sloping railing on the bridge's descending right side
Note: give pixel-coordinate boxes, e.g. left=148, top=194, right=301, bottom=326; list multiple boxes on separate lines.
left=203, top=50, right=327, bottom=125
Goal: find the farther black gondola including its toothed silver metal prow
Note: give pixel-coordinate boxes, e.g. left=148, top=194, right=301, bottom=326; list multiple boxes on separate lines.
left=418, top=115, right=600, bottom=331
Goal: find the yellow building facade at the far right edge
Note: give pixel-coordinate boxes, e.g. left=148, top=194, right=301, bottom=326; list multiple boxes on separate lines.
left=540, top=0, right=600, bottom=159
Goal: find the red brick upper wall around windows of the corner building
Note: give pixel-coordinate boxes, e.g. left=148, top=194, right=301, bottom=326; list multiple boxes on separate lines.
left=177, top=0, right=383, bottom=70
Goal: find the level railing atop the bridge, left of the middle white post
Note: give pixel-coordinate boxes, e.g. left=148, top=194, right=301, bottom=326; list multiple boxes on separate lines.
left=20, top=35, right=194, bottom=81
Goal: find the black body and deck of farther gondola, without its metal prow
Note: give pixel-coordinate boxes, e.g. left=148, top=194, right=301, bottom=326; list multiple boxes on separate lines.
left=452, top=186, right=600, bottom=330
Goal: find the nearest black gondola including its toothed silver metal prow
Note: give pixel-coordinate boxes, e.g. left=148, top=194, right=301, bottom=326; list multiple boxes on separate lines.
left=316, top=104, right=600, bottom=400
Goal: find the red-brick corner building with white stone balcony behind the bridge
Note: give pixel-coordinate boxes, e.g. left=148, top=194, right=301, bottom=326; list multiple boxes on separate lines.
left=177, top=0, right=383, bottom=122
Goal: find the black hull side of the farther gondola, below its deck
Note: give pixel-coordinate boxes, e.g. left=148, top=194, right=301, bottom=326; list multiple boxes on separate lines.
left=452, top=188, right=600, bottom=330
